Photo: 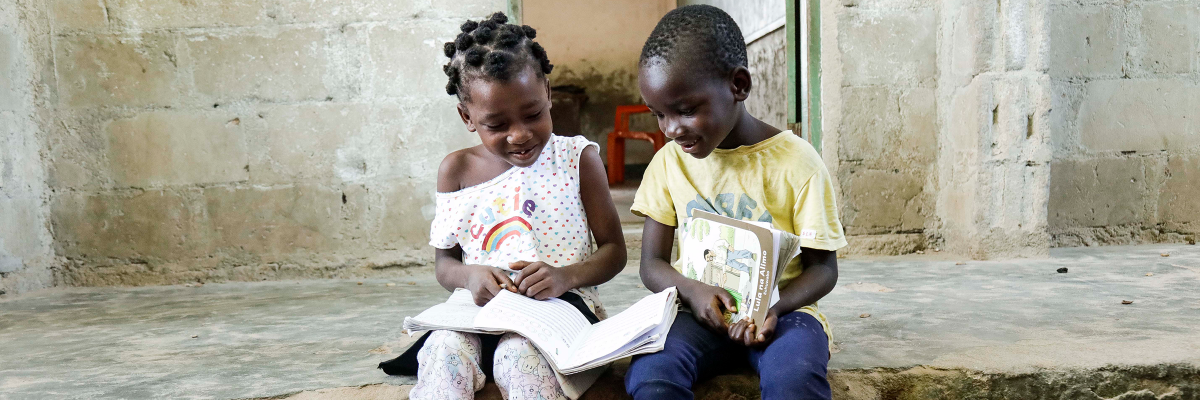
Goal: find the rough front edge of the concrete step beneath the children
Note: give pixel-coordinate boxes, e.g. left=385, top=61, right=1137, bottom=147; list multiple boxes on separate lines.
left=265, top=360, right=1200, bottom=400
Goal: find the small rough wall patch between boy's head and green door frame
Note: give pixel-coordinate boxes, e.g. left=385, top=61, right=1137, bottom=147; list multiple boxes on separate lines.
left=745, top=29, right=787, bottom=130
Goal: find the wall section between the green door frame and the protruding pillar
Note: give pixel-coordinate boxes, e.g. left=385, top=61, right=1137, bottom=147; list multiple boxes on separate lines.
left=821, top=0, right=938, bottom=255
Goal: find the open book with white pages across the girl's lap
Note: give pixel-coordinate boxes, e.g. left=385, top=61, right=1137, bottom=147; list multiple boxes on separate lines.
left=404, top=287, right=679, bottom=375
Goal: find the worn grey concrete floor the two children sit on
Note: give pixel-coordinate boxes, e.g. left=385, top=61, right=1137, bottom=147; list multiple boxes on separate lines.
left=0, top=241, right=1200, bottom=399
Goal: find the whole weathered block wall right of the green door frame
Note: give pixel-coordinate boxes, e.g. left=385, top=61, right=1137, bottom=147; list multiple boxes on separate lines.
left=821, top=0, right=1200, bottom=258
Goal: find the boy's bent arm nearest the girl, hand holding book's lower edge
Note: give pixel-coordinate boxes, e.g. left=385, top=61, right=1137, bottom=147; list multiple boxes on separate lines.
left=641, top=217, right=737, bottom=333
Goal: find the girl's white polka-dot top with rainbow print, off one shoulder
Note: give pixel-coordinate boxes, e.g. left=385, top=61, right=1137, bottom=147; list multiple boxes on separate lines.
left=430, top=135, right=606, bottom=320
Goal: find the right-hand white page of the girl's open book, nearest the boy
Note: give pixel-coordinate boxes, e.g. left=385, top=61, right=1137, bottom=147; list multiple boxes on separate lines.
left=560, top=288, right=674, bottom=369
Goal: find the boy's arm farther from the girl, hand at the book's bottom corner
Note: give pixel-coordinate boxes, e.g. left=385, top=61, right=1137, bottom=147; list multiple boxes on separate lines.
left=730, top=247, right=838, bottom=346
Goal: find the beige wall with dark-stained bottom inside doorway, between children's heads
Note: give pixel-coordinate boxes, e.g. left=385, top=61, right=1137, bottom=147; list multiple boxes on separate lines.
left=522, top=0, right=674, bottom=163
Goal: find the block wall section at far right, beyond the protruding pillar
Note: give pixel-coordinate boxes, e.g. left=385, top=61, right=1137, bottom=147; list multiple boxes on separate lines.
left=1050, top=1, right=1200, bottom=246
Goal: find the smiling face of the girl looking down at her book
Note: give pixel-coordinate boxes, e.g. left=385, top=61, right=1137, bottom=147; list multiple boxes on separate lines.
left=458, top=67, right=553, bottom=167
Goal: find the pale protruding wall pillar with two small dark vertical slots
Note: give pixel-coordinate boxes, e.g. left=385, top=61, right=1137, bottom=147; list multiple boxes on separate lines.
left=936, top=0, right=1051, bottom=258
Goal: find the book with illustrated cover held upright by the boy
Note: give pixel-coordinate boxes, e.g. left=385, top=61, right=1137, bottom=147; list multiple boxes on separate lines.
left=674, top=210, right=800, bottom=327
